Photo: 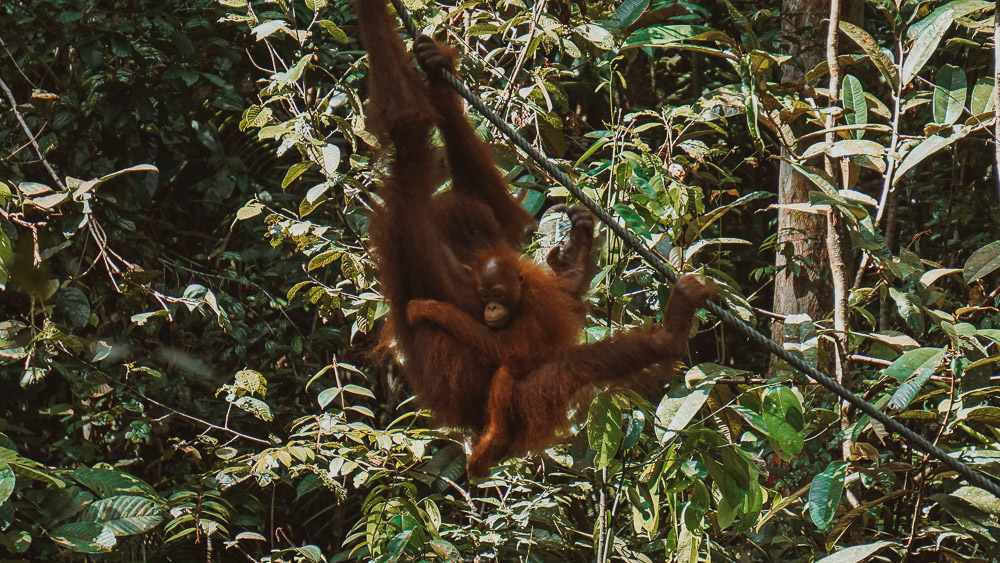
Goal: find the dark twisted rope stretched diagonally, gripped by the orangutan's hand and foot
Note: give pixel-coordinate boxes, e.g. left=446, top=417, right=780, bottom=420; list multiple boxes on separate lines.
left=382, top=0, right=1000, bottom=497
